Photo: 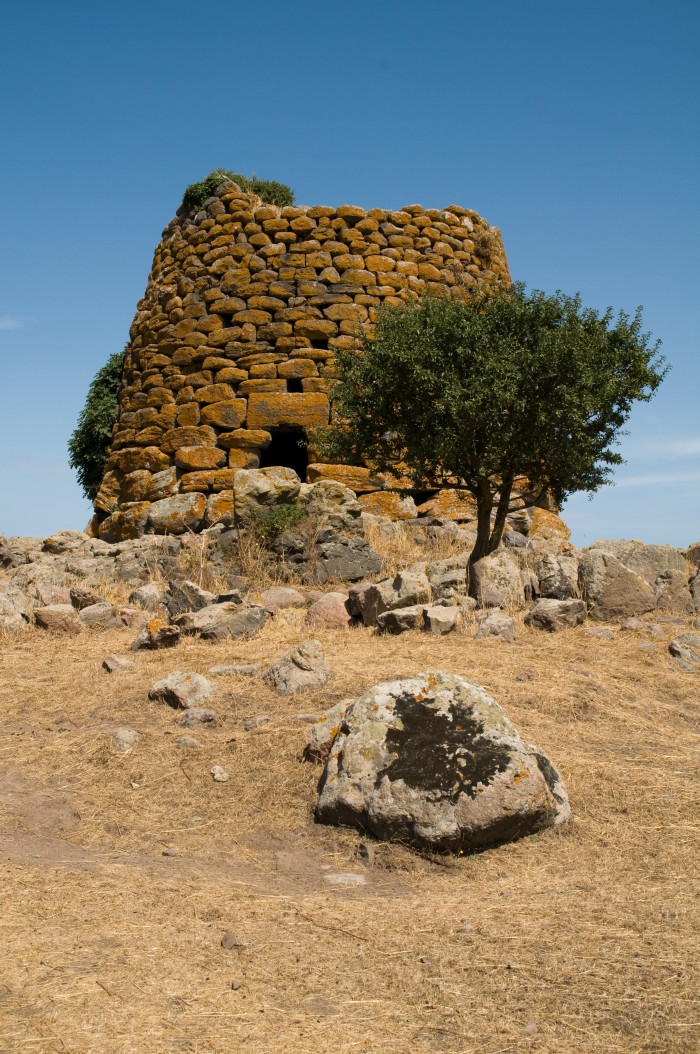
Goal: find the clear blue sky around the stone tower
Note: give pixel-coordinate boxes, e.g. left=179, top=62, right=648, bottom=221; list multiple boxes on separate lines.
left=0, top=0, right=700, bottom=545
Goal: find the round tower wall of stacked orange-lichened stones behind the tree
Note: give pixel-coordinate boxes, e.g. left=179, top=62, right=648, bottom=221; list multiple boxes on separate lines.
left=94, top=183, right=510, bottom=541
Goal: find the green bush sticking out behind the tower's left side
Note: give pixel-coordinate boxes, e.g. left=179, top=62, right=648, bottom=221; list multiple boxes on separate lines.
left=69, top=350, right=125, bottom=502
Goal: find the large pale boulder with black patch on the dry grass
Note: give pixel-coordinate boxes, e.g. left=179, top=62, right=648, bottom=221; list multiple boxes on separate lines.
left=316, top=671, right=569, bottom=852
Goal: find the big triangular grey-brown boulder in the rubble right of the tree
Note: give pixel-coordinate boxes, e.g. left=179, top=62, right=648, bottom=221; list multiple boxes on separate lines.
left=579, top=548, right=657, bottom=622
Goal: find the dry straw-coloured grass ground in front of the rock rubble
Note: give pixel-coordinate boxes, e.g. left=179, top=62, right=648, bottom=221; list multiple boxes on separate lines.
left=0, top=611, right=700, bottom=1054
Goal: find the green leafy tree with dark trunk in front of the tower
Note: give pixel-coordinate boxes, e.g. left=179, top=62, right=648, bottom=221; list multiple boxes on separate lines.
left=320, top=284, right=666, bottom=560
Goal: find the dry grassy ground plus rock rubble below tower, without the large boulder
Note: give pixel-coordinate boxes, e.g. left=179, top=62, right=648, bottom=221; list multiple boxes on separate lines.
left=0, top=491, right=700, bottom=1054
